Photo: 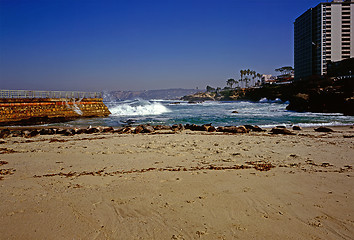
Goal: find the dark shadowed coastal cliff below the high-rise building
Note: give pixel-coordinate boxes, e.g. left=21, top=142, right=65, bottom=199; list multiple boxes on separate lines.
left=181, top=78, right=354, bottom=116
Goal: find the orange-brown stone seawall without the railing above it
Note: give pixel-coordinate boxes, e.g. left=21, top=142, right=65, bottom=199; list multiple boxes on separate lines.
left=0, top=98, right=110, bottom=126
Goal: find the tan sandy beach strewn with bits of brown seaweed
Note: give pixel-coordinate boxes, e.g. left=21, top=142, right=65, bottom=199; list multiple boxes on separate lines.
left=0, top=126, right=354, bottom=239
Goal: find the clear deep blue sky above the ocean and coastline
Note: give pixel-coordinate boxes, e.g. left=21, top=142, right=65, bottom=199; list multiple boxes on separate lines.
left=0, top=0, right=320, bottom=91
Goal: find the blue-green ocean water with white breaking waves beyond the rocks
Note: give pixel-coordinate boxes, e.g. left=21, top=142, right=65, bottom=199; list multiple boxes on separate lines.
left=64, top=99, right=354, bottom=127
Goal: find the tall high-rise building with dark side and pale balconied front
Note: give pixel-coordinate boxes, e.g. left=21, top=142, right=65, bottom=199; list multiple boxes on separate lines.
left=294, top=0, right=354, bottom=80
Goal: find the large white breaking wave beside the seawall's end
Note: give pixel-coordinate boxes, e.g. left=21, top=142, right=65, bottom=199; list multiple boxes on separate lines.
left=109, top=100, right=170, bottom=116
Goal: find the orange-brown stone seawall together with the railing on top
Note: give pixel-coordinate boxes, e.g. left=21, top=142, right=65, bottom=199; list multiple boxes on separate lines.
left=0, top=90, right=110, bottom=126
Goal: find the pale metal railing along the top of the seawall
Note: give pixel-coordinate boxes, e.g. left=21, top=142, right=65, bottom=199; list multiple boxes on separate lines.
left=0, top=90, right=102, bottom=98
